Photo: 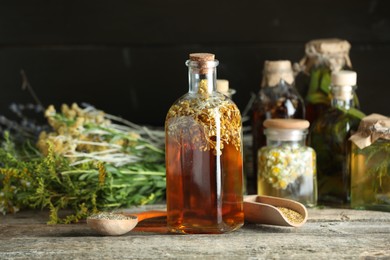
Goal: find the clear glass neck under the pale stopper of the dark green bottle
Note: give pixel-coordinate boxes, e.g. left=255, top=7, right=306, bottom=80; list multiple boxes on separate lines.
left=331, top=86, right=356, bottom=109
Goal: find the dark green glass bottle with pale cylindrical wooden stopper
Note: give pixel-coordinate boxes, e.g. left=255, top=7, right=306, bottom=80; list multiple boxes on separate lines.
left=309, top=70, right=364, bottom=206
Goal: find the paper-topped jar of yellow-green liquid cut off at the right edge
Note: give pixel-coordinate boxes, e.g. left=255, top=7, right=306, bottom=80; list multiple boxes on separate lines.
left=349, top=114, right=390, bottom=212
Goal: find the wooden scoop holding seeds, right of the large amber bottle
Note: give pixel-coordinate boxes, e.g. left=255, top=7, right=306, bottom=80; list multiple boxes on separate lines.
left=244, top=195, right=307, bottom=227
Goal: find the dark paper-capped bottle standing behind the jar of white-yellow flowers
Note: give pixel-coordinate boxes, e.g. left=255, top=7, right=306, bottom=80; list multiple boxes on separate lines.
left=251, top=60, right=305, bottom=194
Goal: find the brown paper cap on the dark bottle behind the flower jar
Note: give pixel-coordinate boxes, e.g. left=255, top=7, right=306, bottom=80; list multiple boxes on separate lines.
left=261, top=60, right=294, bottom=87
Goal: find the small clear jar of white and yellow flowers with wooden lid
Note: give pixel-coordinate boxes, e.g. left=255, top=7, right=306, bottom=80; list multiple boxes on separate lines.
left=258, top=119, right=317, bottom=207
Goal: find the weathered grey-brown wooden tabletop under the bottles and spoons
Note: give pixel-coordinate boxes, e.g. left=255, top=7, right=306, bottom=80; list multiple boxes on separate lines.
left=0, top=206, right=390, bottom=259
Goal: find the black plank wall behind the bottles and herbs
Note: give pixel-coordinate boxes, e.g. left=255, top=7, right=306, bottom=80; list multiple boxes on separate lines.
left=0, top=0, right=390, bottom=126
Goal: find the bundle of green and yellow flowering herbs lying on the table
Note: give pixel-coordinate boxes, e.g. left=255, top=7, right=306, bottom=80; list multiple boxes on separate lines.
left=0, top=104, right=165, bottom=224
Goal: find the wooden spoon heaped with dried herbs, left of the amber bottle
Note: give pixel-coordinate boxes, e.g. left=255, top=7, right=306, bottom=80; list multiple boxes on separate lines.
left=87, top=211, right=167, bottom=236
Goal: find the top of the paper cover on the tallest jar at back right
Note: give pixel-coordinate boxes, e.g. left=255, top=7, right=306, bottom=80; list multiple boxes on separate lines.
left=305, top=38, right=351, bottom=55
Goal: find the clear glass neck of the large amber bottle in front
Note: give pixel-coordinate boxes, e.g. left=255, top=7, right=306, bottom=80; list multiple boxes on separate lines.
left=186, top=60, right=218, bottom=94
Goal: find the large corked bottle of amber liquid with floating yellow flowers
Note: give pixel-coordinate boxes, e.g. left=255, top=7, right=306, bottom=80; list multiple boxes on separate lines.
left=165, top=53, right=244, bottom=234
